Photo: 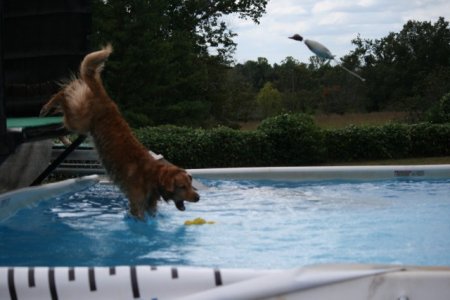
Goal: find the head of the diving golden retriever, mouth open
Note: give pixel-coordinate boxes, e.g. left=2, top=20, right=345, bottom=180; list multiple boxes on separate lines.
left=159, top=166, right=200, bottom=211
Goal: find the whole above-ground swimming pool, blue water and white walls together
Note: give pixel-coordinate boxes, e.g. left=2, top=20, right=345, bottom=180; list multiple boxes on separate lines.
left=0, top=165, right=450, bottom=300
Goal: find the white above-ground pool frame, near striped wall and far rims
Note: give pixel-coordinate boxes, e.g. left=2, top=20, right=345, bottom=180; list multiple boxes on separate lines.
left=0, top=165, right=450, bottom=300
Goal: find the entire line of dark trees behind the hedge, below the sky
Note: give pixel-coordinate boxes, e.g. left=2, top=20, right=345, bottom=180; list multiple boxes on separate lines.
left=90, top=0, right=450, bottom=127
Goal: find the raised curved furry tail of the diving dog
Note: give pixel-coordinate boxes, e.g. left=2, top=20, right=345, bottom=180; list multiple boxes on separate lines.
left=80, top=44, right=112, bottom=93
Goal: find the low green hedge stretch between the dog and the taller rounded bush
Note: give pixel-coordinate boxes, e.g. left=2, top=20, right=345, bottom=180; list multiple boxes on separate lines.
left=135, top=126, right=270, bottom=168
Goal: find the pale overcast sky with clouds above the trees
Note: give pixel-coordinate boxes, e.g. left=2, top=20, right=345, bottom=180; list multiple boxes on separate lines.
left=226, top=0, right=450, bottom=64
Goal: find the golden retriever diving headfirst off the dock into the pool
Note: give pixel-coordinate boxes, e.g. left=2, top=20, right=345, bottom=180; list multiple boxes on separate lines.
left=40, top=45, right=200, bottom=219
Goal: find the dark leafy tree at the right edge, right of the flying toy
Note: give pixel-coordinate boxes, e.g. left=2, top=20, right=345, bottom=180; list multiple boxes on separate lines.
left=350, top=17, right=450, bottom=110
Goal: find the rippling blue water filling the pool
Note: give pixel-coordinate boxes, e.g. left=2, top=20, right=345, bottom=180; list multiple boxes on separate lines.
left=0, top=179, right=450, bottom=268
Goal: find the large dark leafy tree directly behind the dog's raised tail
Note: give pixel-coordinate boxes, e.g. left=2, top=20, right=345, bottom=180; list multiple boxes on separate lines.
left=91, top=0, right=267, bottom=124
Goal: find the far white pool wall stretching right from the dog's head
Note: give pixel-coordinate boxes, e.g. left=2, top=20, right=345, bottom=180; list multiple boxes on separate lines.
left=188, top=165, right=450, bottom=181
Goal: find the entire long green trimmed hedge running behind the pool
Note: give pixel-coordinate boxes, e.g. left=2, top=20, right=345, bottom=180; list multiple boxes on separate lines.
left=135, top=114, right=450, bottom=168
